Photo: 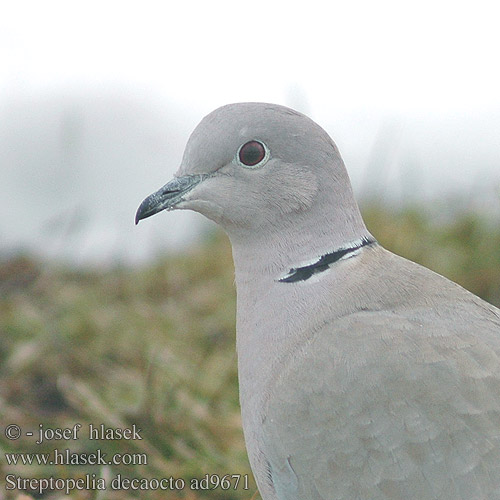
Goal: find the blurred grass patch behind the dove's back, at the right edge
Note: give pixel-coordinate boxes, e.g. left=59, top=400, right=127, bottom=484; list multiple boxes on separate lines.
left=362, top=197, right=500, bottom=307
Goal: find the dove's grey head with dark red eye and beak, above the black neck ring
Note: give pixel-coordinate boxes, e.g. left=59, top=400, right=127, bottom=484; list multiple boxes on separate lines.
left=136, top=103, right=368, bottom=268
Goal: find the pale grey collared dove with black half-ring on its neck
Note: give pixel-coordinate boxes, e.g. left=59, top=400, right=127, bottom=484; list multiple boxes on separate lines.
left=136, top=103, right=500, bottom=500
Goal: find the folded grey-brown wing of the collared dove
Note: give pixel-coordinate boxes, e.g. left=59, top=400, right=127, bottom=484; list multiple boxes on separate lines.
left=263, top=292, right=500, bottom=500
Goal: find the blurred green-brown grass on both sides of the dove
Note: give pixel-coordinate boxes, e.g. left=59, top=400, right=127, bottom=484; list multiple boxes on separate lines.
left=0, top=197, right=500, bottom=500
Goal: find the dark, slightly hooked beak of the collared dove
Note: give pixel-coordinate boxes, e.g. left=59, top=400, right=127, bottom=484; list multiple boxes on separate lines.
left=135, top=174, right=208, bottom=224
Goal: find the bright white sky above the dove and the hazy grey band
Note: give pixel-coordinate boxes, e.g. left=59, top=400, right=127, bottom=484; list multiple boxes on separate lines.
left=0, top=0, right=500, bottom=113
